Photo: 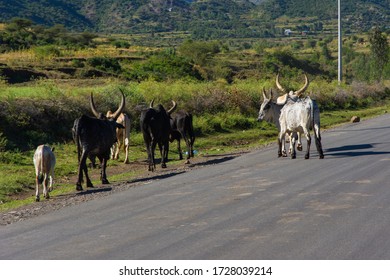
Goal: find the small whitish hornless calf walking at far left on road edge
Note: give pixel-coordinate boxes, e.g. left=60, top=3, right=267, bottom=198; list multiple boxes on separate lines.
left=33, top=145, right=56, bottom=202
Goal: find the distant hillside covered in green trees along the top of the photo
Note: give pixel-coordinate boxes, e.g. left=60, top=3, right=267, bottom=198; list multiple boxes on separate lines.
left=0, top=0, right=390, bottom=37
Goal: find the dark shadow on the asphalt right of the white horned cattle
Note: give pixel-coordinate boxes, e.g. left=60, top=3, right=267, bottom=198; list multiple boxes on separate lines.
left=325, top=143, right=390, bottom=157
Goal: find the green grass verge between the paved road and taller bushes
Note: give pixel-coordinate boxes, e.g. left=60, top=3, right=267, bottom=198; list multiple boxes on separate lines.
left=0, top=100, right=390, bottom=212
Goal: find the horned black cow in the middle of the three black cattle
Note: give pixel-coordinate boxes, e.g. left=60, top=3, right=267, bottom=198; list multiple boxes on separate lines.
left=140, top=101, right=176, bottom=171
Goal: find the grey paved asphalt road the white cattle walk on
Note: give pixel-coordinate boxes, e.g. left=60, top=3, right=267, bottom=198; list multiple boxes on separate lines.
left=0, top=114, right=390, bottom=260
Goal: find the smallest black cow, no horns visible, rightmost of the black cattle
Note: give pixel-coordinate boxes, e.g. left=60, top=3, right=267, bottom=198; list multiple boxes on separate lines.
left=169, top=110, right=195, bottom=163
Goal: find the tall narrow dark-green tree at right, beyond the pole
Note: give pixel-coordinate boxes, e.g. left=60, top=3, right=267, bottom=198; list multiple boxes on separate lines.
left=369, top=28, right=390, bottom=81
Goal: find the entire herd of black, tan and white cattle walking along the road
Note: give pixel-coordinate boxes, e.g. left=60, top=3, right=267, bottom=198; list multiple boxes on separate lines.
left=33, top=74, right=324, bottom=201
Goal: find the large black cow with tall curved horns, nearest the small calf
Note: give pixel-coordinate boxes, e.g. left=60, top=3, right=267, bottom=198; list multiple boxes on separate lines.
left=72, top=93, right=125, bottom=191
